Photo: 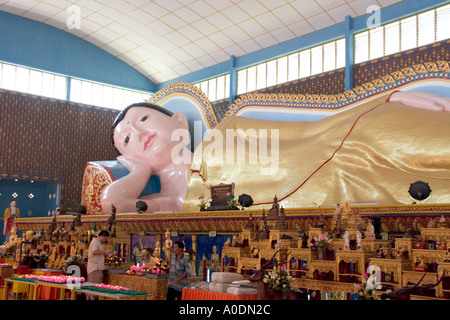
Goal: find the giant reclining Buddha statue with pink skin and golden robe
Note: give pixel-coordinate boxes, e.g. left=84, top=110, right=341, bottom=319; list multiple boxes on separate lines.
left=101, top=91, right=450, bottom=214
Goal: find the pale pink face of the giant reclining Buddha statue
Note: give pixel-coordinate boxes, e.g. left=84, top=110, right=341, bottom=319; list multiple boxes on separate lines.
left=114, top=107, right=188, bottom=166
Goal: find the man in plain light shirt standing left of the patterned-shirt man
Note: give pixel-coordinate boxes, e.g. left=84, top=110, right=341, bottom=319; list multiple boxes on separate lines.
left=86, top=230, right=111, bottom=300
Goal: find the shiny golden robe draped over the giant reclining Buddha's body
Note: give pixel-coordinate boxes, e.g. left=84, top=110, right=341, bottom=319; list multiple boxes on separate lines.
left=183, top=95, right=450, bottom=212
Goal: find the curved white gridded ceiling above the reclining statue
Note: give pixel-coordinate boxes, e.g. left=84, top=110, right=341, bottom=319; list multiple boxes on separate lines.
left=0, top=0, right=399, bottom=83
